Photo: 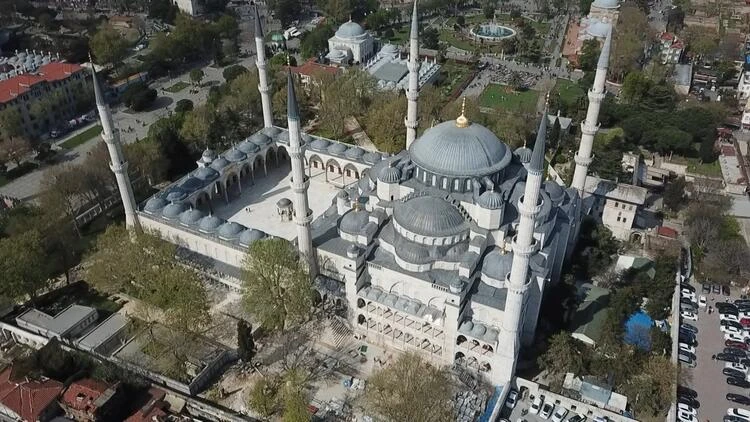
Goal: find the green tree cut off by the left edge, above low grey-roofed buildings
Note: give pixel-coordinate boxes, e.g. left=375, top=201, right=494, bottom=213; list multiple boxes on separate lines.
left=0, top=230, right=48, bottom=300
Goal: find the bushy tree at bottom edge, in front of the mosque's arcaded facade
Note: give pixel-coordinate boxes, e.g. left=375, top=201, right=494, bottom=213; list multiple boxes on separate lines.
left=364, top=352, right=455, bottom=422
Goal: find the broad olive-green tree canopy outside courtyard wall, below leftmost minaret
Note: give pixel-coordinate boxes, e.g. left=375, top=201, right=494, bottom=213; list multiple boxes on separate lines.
left=86, top=225, right=209, bottom=332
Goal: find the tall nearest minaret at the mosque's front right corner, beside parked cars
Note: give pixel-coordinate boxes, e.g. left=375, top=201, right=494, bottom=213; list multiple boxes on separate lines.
left=498, top=107, right=547, bottom=381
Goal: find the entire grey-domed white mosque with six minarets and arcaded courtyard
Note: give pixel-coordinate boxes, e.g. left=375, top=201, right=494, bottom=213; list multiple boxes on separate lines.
left=94, top=2, right=611, bottom=385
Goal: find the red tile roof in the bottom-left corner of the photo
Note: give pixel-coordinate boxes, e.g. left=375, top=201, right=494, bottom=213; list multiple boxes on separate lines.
left=0, top=367, right=63, bottom=421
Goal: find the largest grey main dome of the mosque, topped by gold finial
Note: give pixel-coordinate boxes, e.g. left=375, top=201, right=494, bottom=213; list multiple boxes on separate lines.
left=409, top=120, right=511, bottom=176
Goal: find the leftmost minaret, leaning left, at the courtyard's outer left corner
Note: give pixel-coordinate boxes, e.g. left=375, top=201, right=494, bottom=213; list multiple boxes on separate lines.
left=89, top=57, right=141, bottom=230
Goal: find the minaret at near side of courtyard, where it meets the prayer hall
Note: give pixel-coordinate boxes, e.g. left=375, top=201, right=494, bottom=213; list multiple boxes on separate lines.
left=286, top=70, right=318, bottom=278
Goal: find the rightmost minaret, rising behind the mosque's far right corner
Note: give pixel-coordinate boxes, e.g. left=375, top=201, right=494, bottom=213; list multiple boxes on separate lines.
left=571, top=24, right=612, bottom=193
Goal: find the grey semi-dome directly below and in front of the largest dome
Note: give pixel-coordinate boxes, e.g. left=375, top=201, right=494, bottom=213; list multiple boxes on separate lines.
left=393, top=195, right=467, bottom=237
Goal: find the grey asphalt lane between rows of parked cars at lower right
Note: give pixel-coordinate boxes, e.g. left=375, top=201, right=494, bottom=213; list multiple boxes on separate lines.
left=680, top=283, right=750, bottom=422
